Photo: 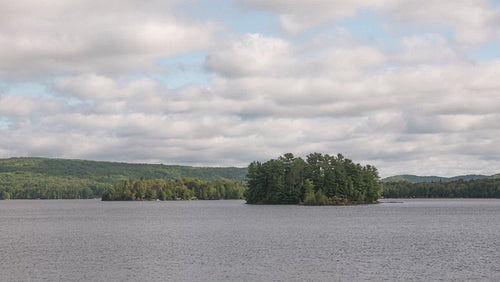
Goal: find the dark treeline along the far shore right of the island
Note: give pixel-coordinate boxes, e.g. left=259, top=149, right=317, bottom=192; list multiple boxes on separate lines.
left=382, top=179, right=500, bottom=198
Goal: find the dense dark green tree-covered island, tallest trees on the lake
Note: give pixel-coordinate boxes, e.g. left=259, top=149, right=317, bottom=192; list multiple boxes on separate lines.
left=245, top=153, right=381, bottom=205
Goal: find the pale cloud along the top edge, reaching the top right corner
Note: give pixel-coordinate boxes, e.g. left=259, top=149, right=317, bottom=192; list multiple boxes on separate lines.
left=237, top=0, right=500, bottom=47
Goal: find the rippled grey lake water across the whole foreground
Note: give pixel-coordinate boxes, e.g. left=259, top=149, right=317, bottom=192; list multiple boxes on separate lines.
left=0, top=199, right=500, bottom=281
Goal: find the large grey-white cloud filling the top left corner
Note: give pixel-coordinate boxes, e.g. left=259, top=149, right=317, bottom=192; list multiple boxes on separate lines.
left=0, top=0, right=215, bottom=78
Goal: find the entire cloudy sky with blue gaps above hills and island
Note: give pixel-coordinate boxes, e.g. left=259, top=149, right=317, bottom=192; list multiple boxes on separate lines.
left=0, top=0, right=500, bottom=177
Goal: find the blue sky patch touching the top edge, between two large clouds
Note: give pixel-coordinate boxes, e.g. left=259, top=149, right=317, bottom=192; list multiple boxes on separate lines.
left=177, top=0, right=280, bottom=36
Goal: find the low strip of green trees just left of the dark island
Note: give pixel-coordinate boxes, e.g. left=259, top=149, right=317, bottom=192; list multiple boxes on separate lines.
left=102, top=178, right=245, bottom=201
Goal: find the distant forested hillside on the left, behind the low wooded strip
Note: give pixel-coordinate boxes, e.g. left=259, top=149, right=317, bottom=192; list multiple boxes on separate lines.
left=0, top=158, right=247, bottom=199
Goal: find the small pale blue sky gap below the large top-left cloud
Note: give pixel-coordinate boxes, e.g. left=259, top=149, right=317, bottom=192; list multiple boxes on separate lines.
left=154, top=52, right=210, bottom=89
